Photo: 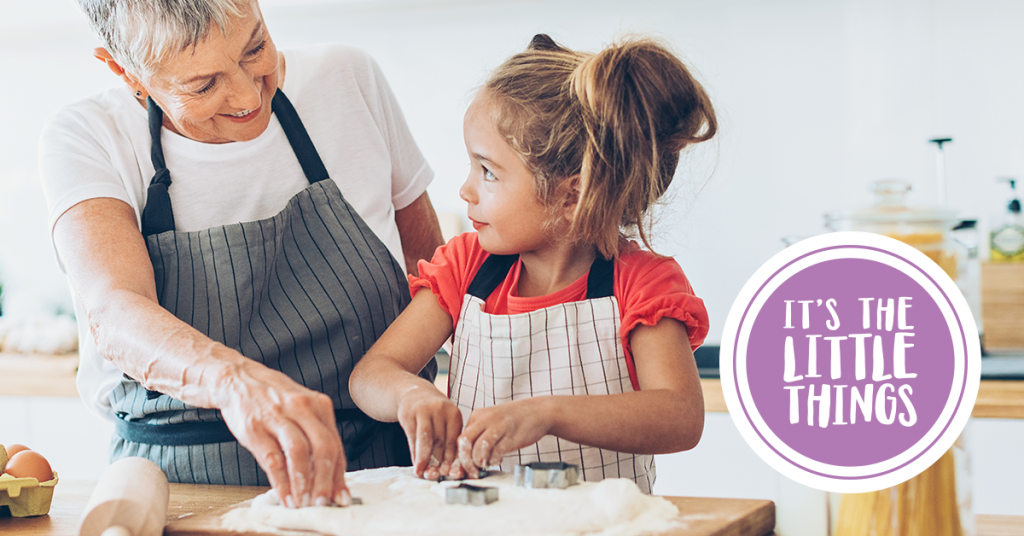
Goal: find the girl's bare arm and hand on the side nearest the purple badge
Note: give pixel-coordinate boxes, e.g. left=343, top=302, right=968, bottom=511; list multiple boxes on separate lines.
left=459, top=318, right=703, bottom=473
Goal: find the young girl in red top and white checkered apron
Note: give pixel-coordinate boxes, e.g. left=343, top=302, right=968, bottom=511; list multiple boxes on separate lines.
left=349, top=35, right=717, bottom=493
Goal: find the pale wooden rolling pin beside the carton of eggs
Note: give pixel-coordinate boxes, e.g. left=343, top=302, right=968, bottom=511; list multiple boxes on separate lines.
left=78, top=458, right=170, bottom=536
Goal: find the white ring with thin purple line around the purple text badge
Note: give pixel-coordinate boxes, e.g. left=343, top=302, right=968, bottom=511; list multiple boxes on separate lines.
left=719, top=232, right=981, bottom=493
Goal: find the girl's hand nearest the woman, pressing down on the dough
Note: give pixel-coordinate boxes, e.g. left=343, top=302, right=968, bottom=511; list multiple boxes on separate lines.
left=398, top=381, right=462, bottom=480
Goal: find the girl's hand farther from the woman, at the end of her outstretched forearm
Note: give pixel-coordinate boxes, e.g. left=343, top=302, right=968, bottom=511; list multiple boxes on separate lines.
left=459, top=397, right=553, bottom=479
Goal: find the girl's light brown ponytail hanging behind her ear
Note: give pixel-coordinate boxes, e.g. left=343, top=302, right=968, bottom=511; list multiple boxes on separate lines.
left=570, top=39, right=718, bottom=256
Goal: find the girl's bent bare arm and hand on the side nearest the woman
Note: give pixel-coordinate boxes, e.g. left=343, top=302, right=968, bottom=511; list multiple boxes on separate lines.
left=348, top=289, right=462, bottom=480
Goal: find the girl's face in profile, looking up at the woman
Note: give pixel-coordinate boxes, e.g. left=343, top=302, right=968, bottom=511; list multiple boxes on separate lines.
left=459, top=90, right=558, bottom=255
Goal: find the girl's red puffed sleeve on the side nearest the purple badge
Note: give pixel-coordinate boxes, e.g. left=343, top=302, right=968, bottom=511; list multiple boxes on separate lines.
left=614, top=246, right=709, bottom=355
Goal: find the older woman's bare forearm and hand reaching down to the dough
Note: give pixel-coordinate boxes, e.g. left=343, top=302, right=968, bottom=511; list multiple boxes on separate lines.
left=53, top=198, right=349, bottom=505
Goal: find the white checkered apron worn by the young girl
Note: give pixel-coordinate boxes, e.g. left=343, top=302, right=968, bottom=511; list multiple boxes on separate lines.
left=449, top=255, right=654, bottom=493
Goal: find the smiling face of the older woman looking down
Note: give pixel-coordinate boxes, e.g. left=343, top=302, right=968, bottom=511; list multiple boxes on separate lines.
left=145, top=2, right=280, bottom=143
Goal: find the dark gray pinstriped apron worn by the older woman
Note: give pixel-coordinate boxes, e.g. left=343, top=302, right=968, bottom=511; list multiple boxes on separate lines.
left=110, top=90, right=437, bottom=486
